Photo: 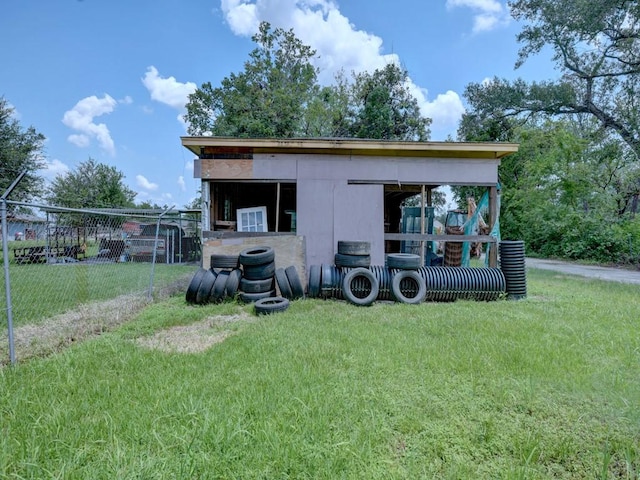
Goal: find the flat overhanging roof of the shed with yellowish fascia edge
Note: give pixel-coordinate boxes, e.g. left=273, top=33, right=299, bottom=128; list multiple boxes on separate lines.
left=180, top=136, right=519, bottom=159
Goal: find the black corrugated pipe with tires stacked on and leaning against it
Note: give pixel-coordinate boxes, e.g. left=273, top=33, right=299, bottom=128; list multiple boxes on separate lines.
left=307, top=241, right=505, bottom=306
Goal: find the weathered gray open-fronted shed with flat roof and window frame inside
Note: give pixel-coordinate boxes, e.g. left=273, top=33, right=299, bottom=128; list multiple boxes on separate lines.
left=181, top=136, right=518, bottom=267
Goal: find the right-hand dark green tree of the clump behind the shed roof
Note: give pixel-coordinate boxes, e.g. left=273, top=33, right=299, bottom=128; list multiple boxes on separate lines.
left=349, top=63, right=431, bottom=141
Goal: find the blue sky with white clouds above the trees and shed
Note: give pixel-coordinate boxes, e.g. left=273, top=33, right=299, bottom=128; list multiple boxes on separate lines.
left=0, top=0, right=555, bottom=207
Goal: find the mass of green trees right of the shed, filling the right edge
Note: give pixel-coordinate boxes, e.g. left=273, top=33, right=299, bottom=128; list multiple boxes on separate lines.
left=454, top=0, right=640, bottom=262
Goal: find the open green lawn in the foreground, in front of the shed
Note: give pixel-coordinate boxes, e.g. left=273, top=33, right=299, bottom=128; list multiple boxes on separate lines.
left=0, top=271, right=640, bottom=479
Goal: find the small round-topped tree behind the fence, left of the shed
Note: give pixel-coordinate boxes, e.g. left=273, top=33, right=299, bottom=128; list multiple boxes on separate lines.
left=47, top=158, right=136, bottom=208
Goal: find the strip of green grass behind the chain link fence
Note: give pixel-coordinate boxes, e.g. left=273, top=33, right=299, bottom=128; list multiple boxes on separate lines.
left=0, top=262, right=197, bottom=326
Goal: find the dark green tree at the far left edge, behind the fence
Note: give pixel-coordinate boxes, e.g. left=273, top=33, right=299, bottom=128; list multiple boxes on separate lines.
left=0, top=97, right=45, bottom=210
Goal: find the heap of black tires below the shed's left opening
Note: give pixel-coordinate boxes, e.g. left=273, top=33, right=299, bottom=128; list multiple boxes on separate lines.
left=185, top=246, right=304, bottom=314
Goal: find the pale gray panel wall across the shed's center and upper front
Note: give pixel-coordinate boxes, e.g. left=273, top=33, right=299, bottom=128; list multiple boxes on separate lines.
left=203, top=154, right=500, bottom=266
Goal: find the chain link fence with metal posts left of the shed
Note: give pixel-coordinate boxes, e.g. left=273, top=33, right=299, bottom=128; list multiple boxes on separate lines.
left=0, top=200, right=201, bottom=363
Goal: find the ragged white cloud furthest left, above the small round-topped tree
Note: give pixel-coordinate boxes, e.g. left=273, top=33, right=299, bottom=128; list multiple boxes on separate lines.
left=62, top=94, right=117, bottom=155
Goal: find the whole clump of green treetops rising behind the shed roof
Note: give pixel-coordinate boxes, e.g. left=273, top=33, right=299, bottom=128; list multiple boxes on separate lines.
left=185, top=22, right=431, bottom=140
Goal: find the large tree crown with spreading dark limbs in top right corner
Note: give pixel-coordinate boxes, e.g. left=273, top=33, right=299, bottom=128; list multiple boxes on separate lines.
left=465, top=0, right=640, bottom=158
